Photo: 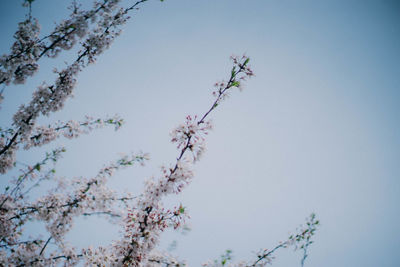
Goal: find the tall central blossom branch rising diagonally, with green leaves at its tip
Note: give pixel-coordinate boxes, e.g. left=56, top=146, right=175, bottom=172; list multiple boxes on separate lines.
left=106, top=56, right=253, bottom=266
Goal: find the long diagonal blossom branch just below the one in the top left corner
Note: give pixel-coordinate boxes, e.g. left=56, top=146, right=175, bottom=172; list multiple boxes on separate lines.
left=0, top=0, right=147, bottom=173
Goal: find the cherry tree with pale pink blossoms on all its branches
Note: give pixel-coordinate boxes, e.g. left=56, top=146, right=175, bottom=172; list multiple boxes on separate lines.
left=0, top=0, right=319, bottom=266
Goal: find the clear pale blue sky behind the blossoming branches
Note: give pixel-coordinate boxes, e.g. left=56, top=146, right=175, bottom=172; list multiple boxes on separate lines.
left=0, top=0, right=400, bottom=267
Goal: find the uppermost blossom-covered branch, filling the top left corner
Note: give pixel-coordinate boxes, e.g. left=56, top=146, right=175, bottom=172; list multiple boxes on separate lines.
left=0, top=0, right=147, bottom=85
